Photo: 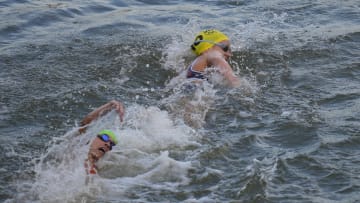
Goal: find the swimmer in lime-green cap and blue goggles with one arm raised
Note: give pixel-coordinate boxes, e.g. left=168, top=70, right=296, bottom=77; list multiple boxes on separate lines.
left=79, top=100, right=124, bottom=174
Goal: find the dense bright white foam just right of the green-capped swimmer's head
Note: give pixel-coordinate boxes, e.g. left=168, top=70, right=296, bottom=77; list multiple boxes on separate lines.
left=120, top=105, right=197, bottom=151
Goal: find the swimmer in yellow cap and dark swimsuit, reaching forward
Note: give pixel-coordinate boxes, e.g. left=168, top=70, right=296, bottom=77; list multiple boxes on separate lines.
left=186, top=29, right=240, bottom=87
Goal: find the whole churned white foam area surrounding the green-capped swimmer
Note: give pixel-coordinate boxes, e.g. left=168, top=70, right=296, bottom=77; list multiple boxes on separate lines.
left=19, top=104, right=199, bottom=202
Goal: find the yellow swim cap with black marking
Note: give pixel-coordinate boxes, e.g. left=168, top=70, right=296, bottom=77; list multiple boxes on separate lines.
left=191, top=29, right=229, bottom=56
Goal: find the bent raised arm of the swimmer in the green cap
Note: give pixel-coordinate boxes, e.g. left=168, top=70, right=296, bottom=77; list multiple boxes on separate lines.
left=79, top=100, right=124, bottom=133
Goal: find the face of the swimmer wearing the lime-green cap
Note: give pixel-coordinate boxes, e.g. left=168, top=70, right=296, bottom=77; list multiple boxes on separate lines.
left=88, top=135, right=115, bottom=162
